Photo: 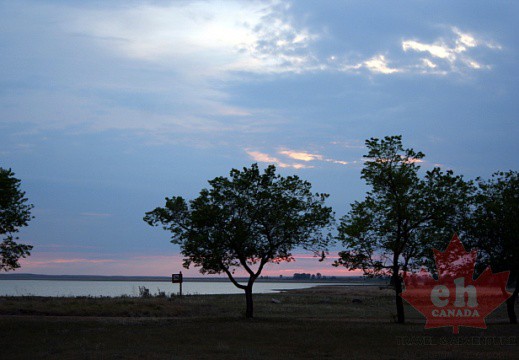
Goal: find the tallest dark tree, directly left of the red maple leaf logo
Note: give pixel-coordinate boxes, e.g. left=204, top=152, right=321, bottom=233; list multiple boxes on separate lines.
left=334, top=136, right=472, bottom=323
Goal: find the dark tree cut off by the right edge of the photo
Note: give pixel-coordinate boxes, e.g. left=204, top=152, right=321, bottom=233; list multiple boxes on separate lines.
left=468, top=170, right=519, bottom=324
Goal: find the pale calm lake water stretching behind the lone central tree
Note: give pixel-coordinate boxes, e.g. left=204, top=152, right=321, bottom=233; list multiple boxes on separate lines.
left=0, top=280, right=352, bottom=296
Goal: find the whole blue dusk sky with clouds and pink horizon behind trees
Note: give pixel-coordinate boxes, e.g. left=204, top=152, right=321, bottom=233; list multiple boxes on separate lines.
left=0, top=0, right=519, bottom=276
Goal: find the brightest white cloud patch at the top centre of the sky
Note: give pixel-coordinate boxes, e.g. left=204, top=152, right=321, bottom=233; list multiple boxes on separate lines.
left=70, top=1, right=318, bottom=76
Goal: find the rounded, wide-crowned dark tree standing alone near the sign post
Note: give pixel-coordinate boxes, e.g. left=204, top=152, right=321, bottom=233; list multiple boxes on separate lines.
left=144, top=164, right=333, bottom=318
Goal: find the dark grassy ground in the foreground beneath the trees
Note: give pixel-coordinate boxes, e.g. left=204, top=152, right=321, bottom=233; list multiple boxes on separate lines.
left=0, top=287, right=519, bottom=359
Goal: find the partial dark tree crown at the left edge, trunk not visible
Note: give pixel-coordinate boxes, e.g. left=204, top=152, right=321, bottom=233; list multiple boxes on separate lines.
left=0, top=168, right=33, bottom=271
